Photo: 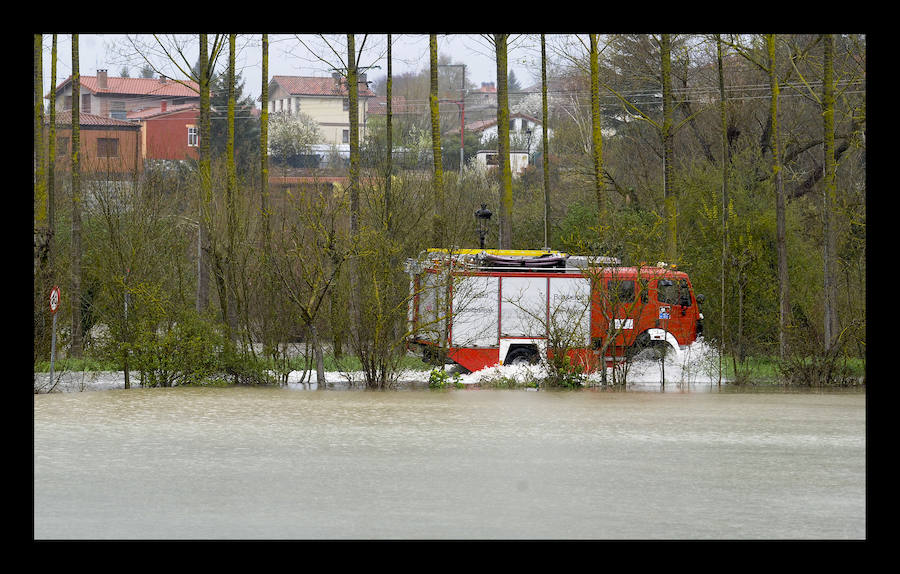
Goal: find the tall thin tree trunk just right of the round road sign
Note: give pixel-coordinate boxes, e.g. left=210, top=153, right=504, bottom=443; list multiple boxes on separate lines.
left=70, top=34, right=83, bottom=357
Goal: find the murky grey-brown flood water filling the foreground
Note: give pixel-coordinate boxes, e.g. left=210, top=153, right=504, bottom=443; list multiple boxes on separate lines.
left=34, top=388, right=866, bottom=539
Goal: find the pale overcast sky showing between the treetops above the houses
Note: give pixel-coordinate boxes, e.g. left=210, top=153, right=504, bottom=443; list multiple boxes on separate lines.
left=42, top=34, right=540, bottom=104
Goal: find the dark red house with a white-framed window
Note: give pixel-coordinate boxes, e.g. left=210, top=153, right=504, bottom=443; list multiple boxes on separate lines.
left=127, top=100, right=200, bottom=160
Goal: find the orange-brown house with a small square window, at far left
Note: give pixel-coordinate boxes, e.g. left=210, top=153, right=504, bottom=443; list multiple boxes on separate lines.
left=45, top=110, right=143, bottom=180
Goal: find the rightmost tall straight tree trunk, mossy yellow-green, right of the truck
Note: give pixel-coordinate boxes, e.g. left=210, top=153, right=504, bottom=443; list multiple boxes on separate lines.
left=822, top=34, right=838, bottom=351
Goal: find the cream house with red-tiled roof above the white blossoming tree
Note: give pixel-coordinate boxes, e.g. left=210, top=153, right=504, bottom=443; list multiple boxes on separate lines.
left=266, top=73, right=375, bottom=147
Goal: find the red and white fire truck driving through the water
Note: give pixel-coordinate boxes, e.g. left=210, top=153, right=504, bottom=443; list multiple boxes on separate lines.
left=406, top=249, right=703, bottom=371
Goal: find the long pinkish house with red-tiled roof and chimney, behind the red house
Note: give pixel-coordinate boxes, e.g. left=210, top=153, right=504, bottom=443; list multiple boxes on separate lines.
left=48, top=70, right=200, bottom=120
